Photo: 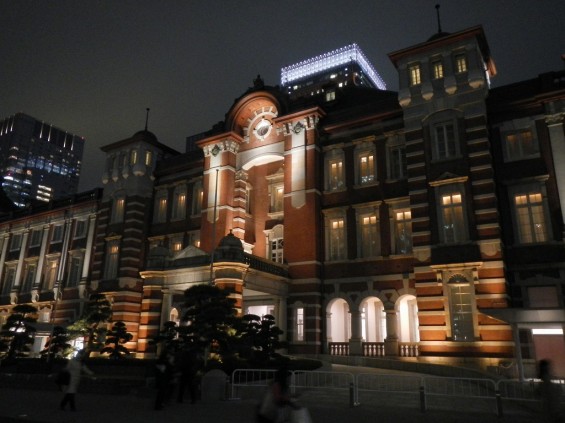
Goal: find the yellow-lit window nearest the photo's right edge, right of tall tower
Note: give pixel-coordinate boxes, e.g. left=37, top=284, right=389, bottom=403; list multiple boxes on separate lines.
left=514, top=191, right=548, bottom=244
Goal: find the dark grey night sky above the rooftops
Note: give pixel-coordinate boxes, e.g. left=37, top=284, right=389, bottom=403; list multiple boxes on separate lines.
left=0, top=0, right=565, bottom=191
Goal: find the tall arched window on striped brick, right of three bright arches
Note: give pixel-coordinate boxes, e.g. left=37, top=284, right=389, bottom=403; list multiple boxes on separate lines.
left=449, top=284, right=475, bottom=342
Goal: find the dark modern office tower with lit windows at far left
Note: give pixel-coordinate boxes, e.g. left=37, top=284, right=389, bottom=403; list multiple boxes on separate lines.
left=0, top=113, right=84, bottom=207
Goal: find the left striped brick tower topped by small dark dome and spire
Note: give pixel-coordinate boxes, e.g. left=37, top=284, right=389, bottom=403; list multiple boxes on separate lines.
left=91, top=129, right=179, bottom=352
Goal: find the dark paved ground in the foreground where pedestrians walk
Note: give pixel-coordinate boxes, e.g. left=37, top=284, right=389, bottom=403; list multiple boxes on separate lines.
left=0, top=367, right=556, bottom=423
